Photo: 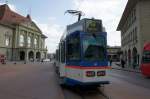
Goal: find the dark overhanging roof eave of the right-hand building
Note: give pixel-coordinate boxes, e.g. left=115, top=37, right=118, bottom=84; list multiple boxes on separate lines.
left=117, top=0, right=141, bottom=31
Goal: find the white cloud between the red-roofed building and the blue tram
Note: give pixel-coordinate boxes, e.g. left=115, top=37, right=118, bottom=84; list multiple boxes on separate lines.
left=34, top=17, right=65, bottom=53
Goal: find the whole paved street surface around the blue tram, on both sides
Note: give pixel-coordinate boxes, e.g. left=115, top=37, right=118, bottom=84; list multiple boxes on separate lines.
left=0, top=62, right=150, bottom=99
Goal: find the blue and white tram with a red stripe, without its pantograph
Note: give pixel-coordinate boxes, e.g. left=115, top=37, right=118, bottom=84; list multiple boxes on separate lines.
left=56, top=18, right=111, bottom=86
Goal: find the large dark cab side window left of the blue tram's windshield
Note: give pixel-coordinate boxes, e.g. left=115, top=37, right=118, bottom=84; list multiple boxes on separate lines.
left=67, top=37, right=80, bottom=60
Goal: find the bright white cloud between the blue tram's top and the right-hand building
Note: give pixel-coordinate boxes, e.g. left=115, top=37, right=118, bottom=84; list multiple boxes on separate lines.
left=73, top=0, right=127, bottom=46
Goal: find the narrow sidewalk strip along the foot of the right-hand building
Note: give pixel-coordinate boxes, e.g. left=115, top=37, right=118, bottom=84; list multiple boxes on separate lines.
left=112, top=62, right=141, bottom=73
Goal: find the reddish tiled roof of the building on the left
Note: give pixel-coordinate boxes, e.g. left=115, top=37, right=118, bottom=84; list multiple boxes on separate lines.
left=0, top=4, right=31, bottom=25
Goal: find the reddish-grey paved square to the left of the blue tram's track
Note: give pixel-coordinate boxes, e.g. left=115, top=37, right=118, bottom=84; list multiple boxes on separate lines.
left=0, top=63, right=64, bottom=99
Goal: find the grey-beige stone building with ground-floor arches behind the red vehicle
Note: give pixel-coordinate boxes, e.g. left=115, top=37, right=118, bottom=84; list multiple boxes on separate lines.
left=117, top=0, right=150, bottom=67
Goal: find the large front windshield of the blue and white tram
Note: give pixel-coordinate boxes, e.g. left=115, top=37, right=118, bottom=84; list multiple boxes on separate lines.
left=83, top=36, right=106, bottom=61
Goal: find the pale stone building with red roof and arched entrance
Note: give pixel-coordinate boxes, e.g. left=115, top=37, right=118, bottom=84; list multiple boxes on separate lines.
left=0, top=4, right=47, bottom=61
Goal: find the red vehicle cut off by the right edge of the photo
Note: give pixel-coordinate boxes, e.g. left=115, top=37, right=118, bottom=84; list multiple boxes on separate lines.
left=140, top=42, right=150, bottom=77
